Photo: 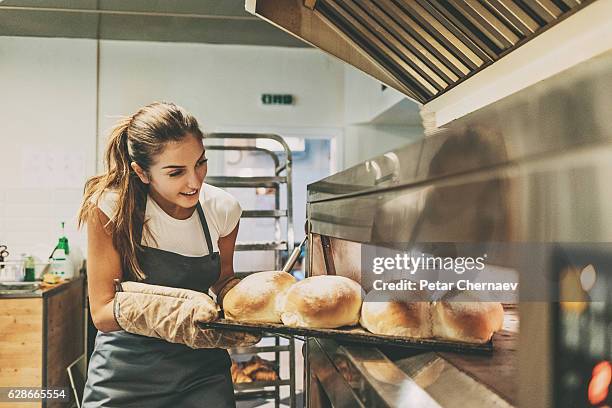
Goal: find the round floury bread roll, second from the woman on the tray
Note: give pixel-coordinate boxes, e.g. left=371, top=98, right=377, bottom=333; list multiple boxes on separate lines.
left=281, top=275, right=362, bottom=329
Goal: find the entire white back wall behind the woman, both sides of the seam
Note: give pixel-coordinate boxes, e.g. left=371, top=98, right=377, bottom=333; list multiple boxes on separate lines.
left=0, top=37, right=426, bottom=268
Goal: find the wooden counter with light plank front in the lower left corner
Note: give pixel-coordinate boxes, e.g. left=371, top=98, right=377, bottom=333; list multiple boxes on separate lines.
left=0, top=276, right=85, bottom=408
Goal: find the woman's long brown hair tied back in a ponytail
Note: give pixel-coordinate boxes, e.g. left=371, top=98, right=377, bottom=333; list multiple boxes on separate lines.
left=78, top=102, right=203, bottom=280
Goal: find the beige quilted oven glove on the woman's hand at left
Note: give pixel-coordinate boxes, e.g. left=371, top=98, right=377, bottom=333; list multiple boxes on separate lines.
left=113, top=282, right=261, bottom=349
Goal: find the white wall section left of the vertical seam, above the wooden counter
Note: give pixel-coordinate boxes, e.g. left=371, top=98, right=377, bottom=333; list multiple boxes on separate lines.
left=0, top=37, right=96, bottom=264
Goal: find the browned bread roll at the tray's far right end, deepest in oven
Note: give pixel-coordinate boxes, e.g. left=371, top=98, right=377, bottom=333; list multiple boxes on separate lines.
left=432, top=299, right=504, bottom=343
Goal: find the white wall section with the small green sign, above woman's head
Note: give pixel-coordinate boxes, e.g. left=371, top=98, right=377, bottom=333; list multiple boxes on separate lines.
left=100, top=41, right=344, bottom=171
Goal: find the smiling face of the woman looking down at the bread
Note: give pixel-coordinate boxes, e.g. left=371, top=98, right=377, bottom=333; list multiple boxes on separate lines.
left=133, top=134, right=208, bottom=218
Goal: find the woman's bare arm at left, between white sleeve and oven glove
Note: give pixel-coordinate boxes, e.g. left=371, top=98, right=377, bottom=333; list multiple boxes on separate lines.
left=87, top=208, right=122, bottom=332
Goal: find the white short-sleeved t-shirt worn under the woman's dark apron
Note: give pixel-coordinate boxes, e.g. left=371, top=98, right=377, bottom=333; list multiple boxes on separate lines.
left=98, top=184, right=242, bottom=256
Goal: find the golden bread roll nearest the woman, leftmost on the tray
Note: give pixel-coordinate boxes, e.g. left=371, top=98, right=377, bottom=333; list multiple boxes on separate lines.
left=223, top=271, right=296, bottom=323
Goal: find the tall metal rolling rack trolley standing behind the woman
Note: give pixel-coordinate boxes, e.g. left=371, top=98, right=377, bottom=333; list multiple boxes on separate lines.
left=205, top=133, right=296, bottom=408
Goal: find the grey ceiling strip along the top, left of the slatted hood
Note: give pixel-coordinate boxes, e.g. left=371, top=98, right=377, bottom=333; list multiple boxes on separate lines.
left=0, top=0, right=309, bottom=47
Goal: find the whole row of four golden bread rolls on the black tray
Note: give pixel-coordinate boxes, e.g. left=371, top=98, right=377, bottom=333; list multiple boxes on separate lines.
left=223, top=271, right=504, bottom=343
